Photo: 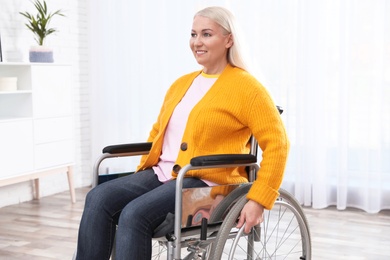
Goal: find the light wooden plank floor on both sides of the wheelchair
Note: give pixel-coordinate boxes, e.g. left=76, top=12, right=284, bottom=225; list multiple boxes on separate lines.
left=0, top=188, right=390, bottom=260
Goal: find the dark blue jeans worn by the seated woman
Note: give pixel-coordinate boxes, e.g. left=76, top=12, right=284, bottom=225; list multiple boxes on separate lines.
left=76, top=169, right=207, bottom=260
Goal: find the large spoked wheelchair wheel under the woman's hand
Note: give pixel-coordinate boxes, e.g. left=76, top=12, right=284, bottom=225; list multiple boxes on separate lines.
left=209, top=190, right=311, bottom=260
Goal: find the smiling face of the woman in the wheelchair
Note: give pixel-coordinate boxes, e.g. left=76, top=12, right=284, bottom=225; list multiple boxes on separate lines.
left=190, top=16, right=233, bottom=74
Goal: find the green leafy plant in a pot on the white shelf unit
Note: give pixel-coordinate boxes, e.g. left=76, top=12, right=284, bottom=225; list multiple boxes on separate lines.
left=19, top=0, right=65, bottom=62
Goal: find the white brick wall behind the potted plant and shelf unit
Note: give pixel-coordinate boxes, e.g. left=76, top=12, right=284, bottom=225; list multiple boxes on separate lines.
left=0, top=0, right=91, bottom=207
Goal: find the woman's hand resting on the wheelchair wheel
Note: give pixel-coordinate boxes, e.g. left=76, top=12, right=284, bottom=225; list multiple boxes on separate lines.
left=236, top=200, right=264, bottom=233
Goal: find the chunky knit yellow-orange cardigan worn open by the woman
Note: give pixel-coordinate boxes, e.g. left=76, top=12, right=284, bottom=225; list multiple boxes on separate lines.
left=137, top=65, right=289, bottom=209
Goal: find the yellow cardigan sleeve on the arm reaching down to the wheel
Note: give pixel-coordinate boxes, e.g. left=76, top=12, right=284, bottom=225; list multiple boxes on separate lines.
left=247, top=83, right=289, bottom=209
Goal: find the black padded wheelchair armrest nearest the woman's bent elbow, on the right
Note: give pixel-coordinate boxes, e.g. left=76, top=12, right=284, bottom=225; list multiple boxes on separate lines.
left=191, top=154, right=257, bottom=166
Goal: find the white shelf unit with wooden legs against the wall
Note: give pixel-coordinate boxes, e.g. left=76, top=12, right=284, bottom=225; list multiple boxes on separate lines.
left=0, top=63, right=76, bottom=202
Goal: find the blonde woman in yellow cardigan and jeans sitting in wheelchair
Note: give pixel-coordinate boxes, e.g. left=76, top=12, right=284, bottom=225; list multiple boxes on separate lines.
left=77, top=7, right=289, bottom=259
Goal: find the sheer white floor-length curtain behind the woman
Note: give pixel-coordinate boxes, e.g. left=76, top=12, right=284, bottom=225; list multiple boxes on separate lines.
left=90, top=0, right=390, bottom=213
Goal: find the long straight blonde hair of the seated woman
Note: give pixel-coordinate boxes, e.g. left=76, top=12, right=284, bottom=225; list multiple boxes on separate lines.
left=194, top=6, right=248, bottom=70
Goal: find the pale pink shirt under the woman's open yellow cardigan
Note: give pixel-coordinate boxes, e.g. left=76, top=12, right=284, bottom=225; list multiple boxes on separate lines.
left=153, top=72, right=219, bottom=186
